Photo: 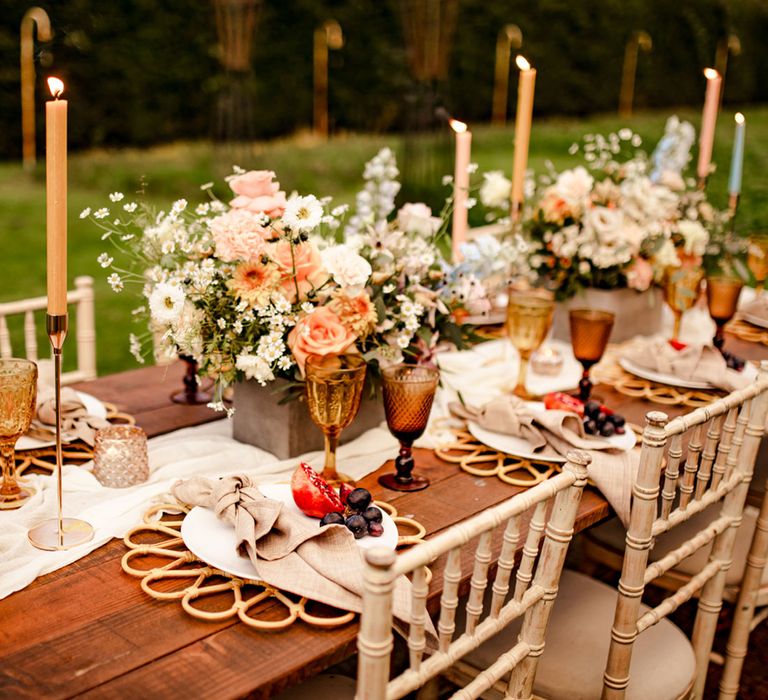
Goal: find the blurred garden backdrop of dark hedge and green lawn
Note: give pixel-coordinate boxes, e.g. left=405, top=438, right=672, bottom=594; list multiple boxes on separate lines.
left=0, top=0, right=768, bottom=373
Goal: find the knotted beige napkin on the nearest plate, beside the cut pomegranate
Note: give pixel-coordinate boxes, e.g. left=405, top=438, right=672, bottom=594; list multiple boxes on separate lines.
left=172, top=475, right=410, bottom=622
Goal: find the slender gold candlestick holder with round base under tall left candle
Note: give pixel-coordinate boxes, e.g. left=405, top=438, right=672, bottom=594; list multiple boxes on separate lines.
left=27, top=314, right=94, bottom=551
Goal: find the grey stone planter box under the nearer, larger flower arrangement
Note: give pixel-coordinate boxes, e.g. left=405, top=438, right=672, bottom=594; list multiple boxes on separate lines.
left=232, top=379, right=385, bottom=459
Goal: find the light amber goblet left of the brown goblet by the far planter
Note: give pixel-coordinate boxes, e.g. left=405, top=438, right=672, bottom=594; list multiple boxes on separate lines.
left=507, top=292, right=555, bottom=399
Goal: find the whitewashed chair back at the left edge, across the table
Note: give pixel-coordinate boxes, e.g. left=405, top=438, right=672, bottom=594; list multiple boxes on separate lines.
left=0, top=276, right=96, bottom=384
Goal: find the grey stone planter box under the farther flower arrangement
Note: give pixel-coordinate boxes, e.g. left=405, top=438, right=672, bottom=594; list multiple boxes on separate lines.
left=552, top=287, right=664, bottom=343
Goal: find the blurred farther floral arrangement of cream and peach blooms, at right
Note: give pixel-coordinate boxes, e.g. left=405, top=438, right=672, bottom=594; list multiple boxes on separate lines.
left=510, top=117, right=728, bottom=300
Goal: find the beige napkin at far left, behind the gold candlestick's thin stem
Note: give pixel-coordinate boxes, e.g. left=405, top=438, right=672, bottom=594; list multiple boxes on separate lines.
left=26, top=386, right=109, bottom=447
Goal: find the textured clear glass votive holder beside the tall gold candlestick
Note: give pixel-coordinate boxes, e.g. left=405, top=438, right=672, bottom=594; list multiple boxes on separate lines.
left=93, top=425, right=149, bottom=489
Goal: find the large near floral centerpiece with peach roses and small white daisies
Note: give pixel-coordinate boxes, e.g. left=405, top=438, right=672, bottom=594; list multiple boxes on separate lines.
left=87, top=149, right=500, bottom=408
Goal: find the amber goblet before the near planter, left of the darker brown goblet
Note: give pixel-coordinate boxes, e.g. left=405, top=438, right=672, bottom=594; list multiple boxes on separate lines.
left=304, top=355, right=366, bottom=484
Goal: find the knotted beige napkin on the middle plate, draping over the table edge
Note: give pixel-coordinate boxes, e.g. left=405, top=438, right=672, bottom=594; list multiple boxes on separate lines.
left=450, top=396, right=639, bottom=525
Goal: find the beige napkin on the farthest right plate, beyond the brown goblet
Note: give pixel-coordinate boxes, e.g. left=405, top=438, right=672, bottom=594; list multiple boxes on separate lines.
left=624, top=338, right=749, bottom=391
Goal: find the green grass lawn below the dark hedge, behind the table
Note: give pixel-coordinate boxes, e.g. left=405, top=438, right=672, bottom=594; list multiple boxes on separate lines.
left=0, top=107, right=768, bottom=374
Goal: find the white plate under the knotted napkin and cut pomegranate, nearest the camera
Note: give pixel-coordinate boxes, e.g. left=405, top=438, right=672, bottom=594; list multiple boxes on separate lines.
left=181, top=484, right=398, bottom=579
